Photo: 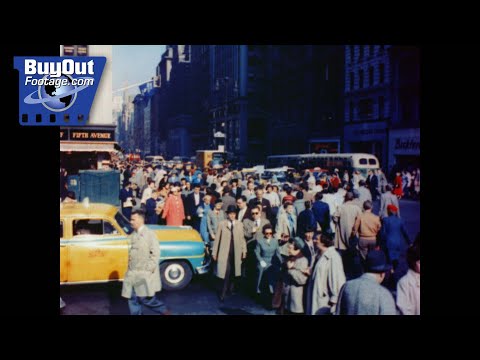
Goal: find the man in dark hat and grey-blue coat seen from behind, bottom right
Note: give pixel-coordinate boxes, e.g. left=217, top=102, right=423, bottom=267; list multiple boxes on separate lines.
left=336, top=250, right=396, bottom=315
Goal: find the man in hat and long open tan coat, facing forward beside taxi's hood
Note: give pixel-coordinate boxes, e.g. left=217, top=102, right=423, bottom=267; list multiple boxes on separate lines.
left=212, top=205, right=247, bottom=302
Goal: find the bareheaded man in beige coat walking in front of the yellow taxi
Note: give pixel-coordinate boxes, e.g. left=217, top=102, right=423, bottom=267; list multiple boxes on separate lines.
left=122, top=210, right=171, bottom=315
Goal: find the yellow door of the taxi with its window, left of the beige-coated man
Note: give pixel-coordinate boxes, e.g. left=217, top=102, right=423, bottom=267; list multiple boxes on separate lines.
left=68, top=218, right=128, bottom=282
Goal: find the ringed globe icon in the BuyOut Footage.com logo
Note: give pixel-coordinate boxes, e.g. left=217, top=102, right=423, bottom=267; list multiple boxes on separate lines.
left=38, top=74, right=77, bottom=111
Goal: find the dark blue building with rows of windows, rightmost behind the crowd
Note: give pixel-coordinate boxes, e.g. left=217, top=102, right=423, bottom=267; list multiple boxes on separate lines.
left=344, top=45, right=420, bottom=171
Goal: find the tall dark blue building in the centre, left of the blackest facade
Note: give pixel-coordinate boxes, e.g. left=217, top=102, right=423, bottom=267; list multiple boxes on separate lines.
left=209, top=45, right=270, bottom=162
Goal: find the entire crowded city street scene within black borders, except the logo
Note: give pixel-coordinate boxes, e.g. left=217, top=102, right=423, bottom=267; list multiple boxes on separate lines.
left=60, top=45, right=422, bottom=315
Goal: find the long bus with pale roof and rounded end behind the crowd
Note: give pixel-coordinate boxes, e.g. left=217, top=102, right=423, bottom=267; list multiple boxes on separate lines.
left=265, top=153, right=380, bottom=177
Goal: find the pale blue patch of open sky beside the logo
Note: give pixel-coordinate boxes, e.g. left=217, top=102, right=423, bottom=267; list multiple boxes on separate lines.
left=112, top=45, right=165, bottom=93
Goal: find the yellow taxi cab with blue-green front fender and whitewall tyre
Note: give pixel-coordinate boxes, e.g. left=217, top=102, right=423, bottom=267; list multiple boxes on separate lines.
left=60, top=203, right=209, bottom=290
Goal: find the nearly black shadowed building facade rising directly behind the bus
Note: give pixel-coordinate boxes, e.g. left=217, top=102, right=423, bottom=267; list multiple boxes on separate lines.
left=267, top=45, right=344, bottom=155
